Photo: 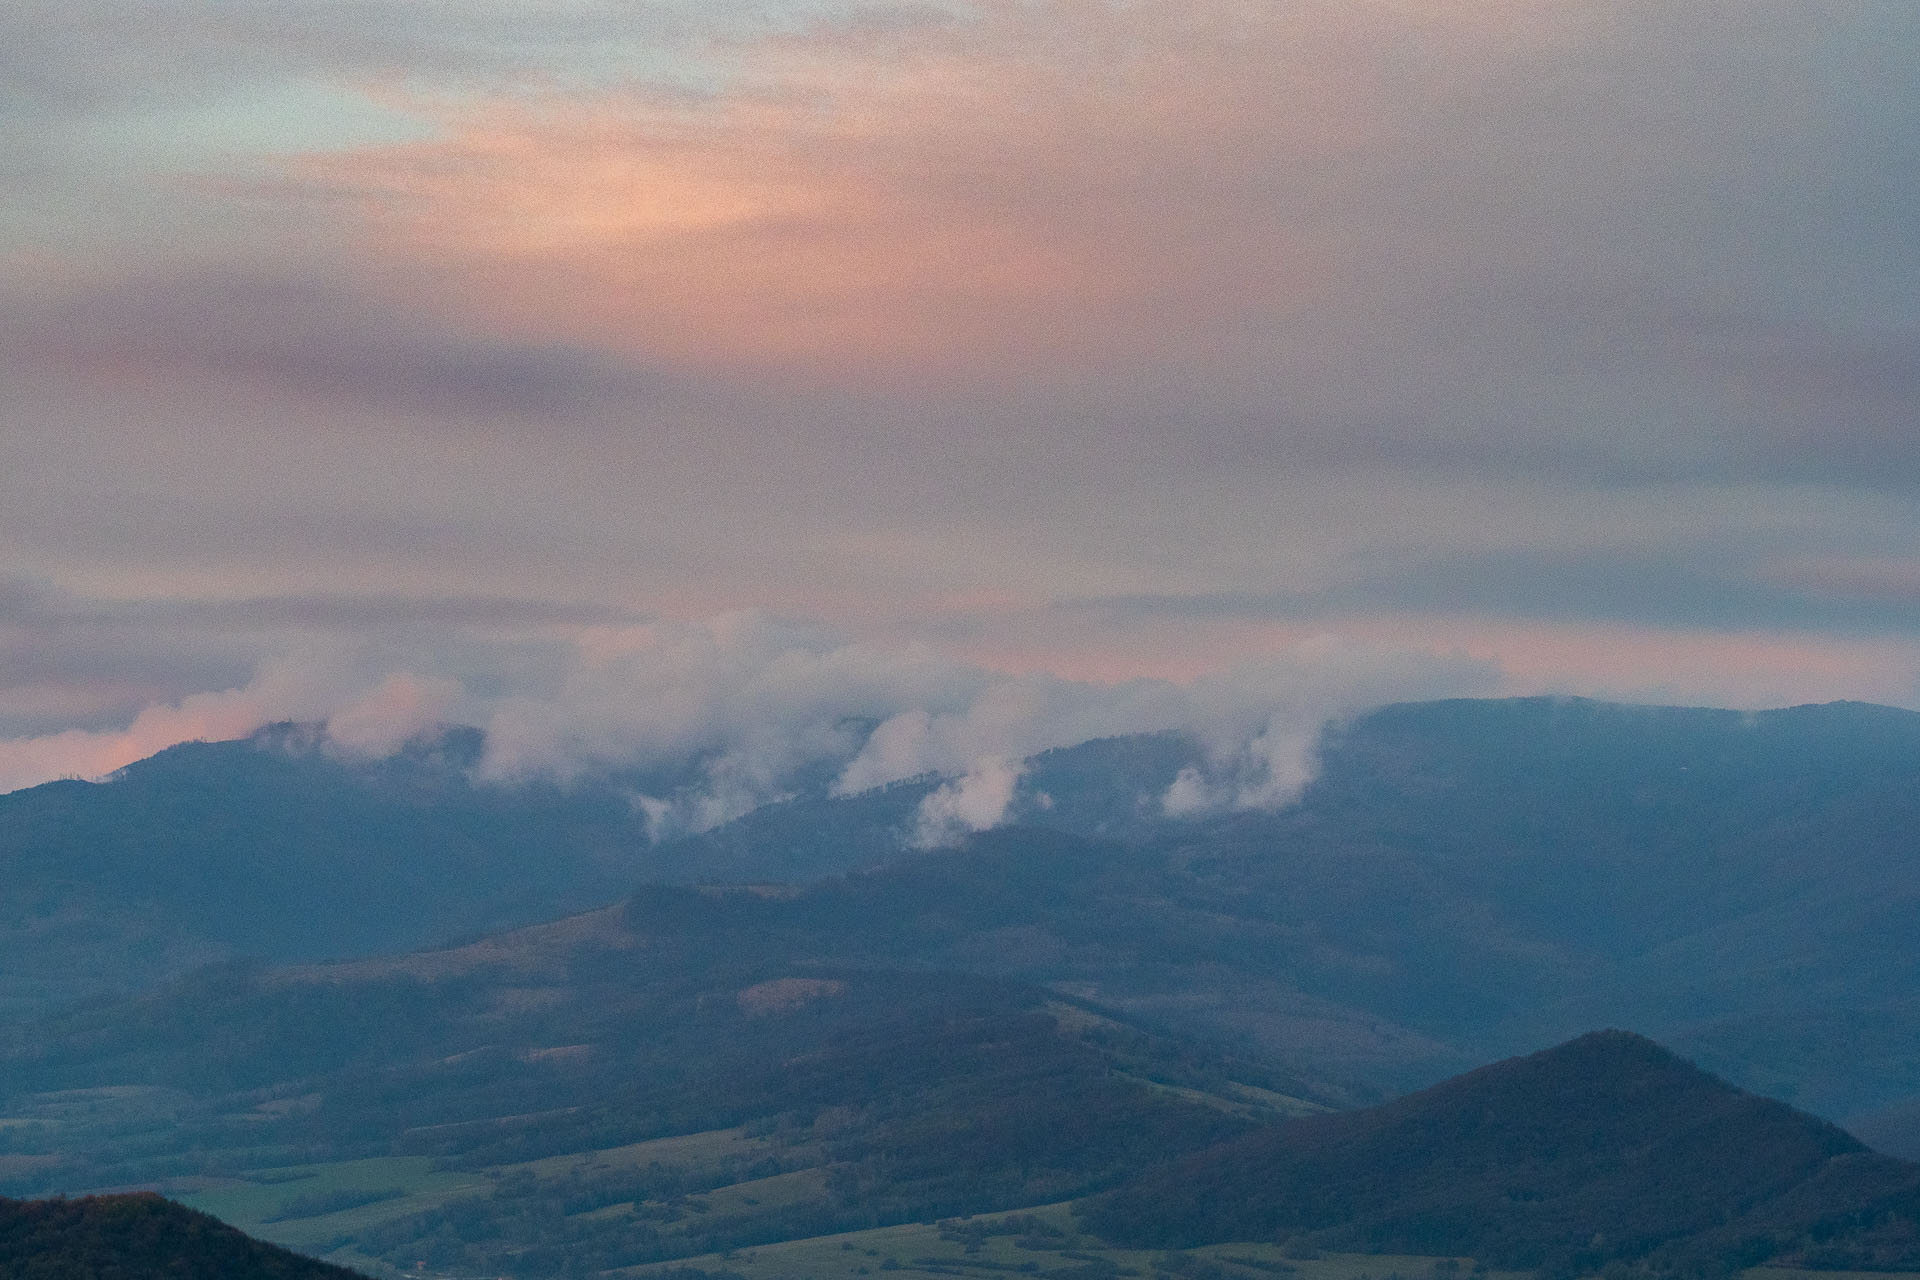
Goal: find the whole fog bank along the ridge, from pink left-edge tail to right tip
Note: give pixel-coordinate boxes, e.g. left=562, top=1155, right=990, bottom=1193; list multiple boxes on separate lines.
left=0, top=612, right=1500, bottom=832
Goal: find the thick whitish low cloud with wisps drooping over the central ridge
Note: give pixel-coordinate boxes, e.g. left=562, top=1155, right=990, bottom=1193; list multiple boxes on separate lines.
left=482, top=614, right=1498, bottom=844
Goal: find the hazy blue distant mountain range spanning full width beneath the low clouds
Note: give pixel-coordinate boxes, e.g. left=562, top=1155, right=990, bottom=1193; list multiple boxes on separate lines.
left=0, top=699, right=1920, bottom=1153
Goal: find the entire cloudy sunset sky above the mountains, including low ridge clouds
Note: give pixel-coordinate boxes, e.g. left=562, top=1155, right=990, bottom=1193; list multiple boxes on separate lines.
left=0, top=0, right=1920, bottom=809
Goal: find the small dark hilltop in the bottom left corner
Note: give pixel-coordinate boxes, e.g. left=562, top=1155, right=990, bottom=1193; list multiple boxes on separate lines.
left=0, top=1196, right=357, bottom=1280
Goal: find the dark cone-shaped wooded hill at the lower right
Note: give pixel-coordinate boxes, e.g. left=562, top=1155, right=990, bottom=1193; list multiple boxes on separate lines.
left=1085, top=1031, right=1920, bottom=1274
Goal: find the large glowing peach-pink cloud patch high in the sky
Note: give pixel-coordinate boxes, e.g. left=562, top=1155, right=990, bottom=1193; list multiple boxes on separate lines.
left=280, top=0, right=1526, bottom=376
